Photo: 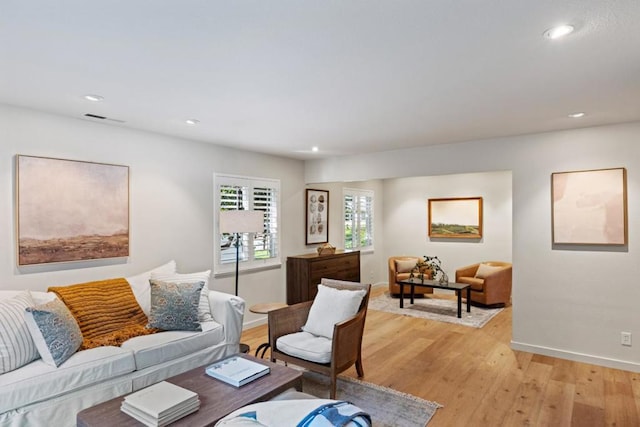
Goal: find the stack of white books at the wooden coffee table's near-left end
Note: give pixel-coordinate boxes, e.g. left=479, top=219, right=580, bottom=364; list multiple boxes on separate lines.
left=120, top=381, right=200, bottom=427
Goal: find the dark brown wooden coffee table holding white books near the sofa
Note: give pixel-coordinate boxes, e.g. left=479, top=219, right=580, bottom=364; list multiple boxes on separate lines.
left=76, top=355, right=302, bottom=427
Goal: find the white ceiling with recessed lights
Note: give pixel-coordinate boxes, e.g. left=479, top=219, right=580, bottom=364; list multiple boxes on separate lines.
left=0, top=0, right=640, bottom=159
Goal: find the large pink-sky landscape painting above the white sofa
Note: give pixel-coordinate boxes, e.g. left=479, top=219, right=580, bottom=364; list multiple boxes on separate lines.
left=16, top=155, right=129, bottom=266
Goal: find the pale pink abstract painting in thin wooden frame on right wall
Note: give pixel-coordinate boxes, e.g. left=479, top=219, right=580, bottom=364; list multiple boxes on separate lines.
left=551, top=168, right=627, bottom=245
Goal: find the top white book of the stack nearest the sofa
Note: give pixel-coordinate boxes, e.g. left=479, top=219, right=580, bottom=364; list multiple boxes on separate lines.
left=124, top=381, right=198, bottom=419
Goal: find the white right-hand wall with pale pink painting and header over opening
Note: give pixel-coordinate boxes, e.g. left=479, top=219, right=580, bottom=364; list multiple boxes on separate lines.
left=305, top=122, right=640, bottom=371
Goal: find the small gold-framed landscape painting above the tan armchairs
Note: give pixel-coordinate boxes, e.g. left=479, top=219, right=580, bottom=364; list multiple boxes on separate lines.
left=427, top=197, right=482, bottom=239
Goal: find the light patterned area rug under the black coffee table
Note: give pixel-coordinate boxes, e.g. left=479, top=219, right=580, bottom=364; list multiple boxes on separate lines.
left=369, top=292, right=504, bottom=328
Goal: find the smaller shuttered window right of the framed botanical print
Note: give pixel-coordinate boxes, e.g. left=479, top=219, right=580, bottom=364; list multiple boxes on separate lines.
left=343, top=188, right=373, bottom=250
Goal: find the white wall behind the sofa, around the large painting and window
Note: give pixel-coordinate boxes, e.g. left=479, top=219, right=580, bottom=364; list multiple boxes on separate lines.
left=0, top=105, right=304, bottom=324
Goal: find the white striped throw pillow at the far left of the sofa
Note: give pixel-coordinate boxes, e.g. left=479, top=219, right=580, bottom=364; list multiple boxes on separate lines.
left=0, top=291, right=38, bottom=374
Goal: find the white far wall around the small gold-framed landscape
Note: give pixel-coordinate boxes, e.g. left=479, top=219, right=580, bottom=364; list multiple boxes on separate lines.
left=381, top=171, right=511, bottom=280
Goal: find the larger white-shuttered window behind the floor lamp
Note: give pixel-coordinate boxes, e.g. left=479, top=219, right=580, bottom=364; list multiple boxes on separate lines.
left=214, top=174, right=280, bottom=273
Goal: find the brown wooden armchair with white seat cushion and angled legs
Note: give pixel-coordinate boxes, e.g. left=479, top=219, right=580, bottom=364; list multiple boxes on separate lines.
left=268, top=279, right=371, bottom=399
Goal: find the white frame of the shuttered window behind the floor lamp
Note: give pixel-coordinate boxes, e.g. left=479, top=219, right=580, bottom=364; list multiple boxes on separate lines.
left=213, top=173, right=282, bottom=276
